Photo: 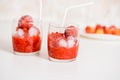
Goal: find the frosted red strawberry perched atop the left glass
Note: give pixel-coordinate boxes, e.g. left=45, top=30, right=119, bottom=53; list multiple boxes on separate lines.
left=18, top=15, right=33, bottom=28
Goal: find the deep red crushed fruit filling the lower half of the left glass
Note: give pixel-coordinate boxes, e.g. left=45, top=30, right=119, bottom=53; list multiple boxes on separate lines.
left=12, top=35, right=41, bottom=53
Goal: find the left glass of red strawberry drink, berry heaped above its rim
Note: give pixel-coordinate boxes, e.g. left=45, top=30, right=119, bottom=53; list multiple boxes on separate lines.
left=12, top=15, right=42, bottom=55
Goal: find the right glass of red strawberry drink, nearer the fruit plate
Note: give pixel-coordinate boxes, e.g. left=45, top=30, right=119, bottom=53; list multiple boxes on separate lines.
left=48, top=25, right=79, bottom=62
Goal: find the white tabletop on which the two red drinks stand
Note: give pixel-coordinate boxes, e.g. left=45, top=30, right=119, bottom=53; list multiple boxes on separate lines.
left=0, top=21, right=120, bottom=80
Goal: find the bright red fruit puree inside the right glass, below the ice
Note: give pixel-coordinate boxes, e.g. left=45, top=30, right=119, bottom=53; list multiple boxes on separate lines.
left=48, top=34, right=79, bottom=60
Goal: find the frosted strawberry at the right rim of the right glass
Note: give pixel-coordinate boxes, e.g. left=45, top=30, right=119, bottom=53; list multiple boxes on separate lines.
left=64, top=26, right=78, bottom=38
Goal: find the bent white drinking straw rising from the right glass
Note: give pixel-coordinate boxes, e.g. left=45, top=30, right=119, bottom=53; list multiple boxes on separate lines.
left=61, top=2, right=94, bottom=27
